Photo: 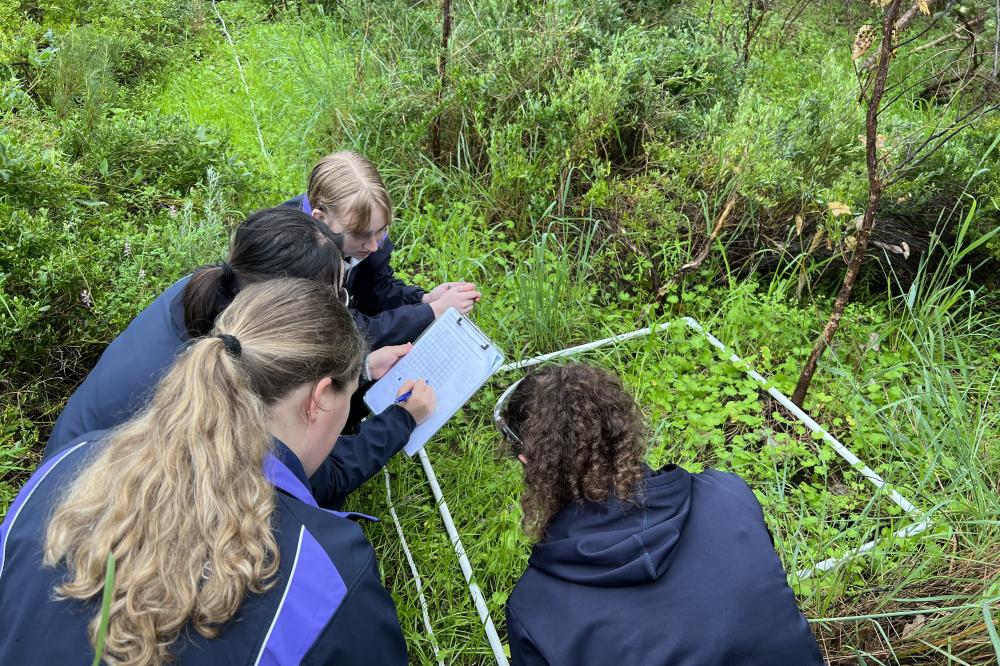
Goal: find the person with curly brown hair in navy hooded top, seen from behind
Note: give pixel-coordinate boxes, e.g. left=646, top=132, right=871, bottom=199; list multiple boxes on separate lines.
left=498, top=363, right=823, bottom=666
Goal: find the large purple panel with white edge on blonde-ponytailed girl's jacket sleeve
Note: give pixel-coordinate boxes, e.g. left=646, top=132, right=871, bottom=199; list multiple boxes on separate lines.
left=256, top=527, right=347, bottom=666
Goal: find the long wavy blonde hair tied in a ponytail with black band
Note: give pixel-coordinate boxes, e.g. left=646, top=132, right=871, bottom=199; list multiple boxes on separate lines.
left=44, top=278, right=364, bottom=664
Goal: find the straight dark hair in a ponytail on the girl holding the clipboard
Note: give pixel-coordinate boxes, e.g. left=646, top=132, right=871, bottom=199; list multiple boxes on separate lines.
left=181, top=206, right=344, bottom=338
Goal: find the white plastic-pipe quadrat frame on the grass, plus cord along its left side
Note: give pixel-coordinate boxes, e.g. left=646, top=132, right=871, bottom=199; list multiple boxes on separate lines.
left=385, top=317, right=933, bottom=666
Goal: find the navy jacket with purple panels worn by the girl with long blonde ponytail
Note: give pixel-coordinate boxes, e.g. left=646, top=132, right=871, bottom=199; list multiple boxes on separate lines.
left=0, top=432, right=407, bottom=665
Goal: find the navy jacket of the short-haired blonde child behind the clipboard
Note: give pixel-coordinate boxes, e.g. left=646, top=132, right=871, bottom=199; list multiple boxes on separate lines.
left=281, top=194, right=434, bottom=349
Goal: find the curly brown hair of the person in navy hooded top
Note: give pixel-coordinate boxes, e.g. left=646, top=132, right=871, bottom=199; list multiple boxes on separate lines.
left=505, top=363, right=647, bottom=540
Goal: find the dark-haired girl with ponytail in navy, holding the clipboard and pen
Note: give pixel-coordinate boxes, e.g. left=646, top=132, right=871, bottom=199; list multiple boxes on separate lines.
left=45, top=207, right=428, bottom=508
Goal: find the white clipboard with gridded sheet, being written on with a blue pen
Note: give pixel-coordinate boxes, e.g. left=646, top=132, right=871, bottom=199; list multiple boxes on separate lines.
left=365, top=308, right=504, bottom=456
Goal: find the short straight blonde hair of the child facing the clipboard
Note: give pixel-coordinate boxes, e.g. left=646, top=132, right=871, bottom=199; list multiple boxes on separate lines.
left=306, top=150, right=392, bottom=233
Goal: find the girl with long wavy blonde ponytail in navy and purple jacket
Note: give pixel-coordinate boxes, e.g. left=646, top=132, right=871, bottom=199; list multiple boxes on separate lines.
left=0, top=278, right=433, bottom=664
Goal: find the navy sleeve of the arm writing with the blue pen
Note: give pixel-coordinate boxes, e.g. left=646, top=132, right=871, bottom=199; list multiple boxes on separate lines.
left=309, top=405, right=416, bottom=509
